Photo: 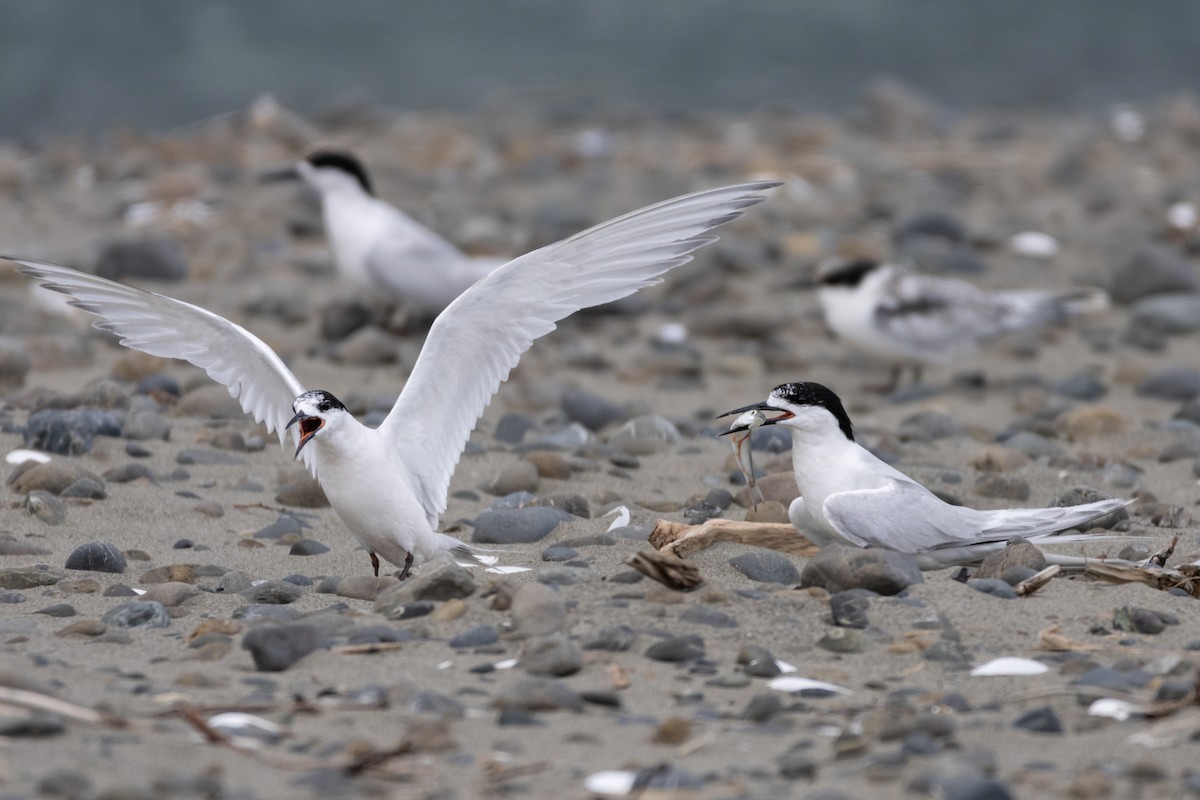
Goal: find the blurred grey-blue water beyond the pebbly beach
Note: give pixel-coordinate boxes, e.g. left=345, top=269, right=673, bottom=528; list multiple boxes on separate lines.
left=0, top=0, right=1200, bottom=136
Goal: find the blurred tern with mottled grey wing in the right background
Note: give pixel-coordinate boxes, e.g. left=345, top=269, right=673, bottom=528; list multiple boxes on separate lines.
left=815, top=259, right=1109, bottom=391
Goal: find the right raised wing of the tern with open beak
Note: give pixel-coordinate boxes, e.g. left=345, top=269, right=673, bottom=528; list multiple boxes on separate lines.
left=379, top=181, right=778, bottom=527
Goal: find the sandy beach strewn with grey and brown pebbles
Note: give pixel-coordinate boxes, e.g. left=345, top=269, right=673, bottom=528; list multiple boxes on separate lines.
left=0, top=98, right=1200, bottom=800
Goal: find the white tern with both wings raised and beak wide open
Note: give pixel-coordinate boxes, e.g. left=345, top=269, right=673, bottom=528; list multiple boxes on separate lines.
left=7, top=181, right=778, bottom=576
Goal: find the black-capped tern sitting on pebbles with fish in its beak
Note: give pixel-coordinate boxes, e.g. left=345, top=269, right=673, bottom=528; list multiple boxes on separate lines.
left=720, top=383, right=1129, bottom=570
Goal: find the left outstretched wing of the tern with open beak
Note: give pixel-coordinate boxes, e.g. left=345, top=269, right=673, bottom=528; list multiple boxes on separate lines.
left=8, top=255, right=305, bottom=453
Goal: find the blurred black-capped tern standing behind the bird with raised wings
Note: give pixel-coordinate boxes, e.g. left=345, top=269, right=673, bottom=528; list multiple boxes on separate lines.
left=263, top=150, right=504, bottom=317
